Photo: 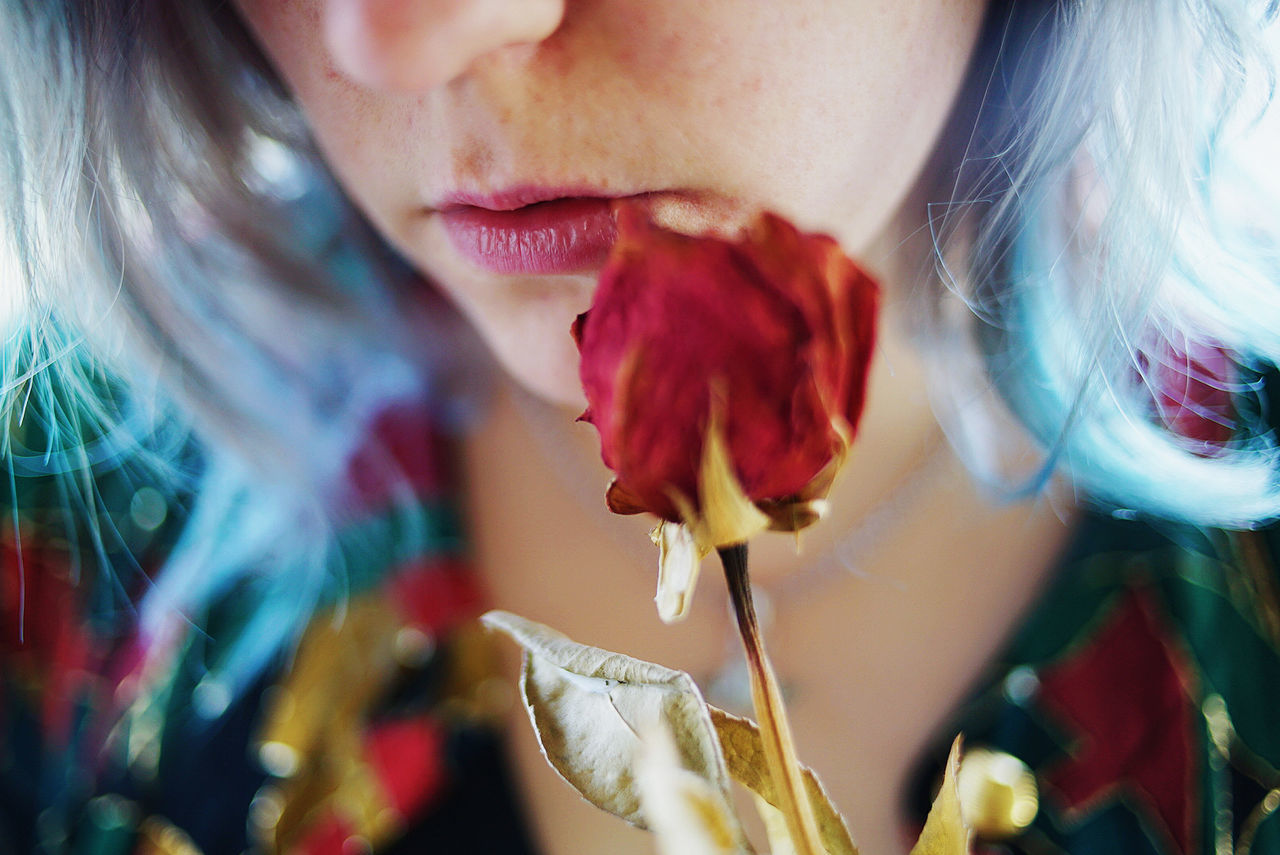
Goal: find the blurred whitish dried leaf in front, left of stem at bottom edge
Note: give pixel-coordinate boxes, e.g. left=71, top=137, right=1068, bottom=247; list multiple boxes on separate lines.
left=635, top=724, right=752, bottom=855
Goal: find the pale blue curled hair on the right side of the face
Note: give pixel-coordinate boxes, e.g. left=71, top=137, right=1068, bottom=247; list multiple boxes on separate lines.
left=931, top=0, right=1280, bottom=527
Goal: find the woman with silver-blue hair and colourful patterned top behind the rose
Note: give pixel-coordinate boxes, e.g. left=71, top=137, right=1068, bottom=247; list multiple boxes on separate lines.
left=0, top=0, right=1280, bottom=852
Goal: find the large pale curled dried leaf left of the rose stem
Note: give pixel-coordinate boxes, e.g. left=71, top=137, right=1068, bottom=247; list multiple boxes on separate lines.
left=481, top=612, right=730, bottom=828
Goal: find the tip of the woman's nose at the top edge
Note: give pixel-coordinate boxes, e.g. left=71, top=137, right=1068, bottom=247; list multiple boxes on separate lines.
left=324, top=0, right=566, bottom=92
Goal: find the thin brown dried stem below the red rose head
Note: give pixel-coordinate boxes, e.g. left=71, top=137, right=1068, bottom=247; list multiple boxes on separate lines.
left=719, top=543, right=826, bottom=855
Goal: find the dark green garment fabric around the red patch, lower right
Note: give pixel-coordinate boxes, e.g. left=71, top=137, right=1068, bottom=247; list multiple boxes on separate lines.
left=922, top=516, right=1280, bottom=855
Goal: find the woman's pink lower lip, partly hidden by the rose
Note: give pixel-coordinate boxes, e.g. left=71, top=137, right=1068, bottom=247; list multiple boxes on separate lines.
left=440, top=198, right=618, bottom=274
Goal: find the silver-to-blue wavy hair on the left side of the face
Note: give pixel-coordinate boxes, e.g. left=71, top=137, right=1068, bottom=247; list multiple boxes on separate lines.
left=0, top=0, right=465, bottom=712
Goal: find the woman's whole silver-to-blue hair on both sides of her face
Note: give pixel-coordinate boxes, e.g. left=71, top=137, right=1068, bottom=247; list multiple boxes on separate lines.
left=0, top=0, right=1280, bottom=707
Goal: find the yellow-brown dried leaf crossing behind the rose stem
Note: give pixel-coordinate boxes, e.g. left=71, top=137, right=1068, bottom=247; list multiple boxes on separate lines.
left=709, top=707, right=858, bottom=855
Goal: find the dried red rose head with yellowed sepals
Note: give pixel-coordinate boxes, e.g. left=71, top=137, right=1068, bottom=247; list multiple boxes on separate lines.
left=573, top=205, right=879, bottom=617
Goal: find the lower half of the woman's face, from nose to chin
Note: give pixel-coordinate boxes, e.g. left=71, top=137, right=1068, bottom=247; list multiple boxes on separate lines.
left=237, top=0, right=986, bottom=402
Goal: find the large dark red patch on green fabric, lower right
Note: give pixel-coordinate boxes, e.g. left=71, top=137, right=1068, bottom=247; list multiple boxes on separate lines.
left=1039, top=590, right=1199, bottom=855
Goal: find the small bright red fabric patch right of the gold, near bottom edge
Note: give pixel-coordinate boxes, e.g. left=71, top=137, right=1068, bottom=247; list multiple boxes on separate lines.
left=365, top=718, right=444, bottom=817
